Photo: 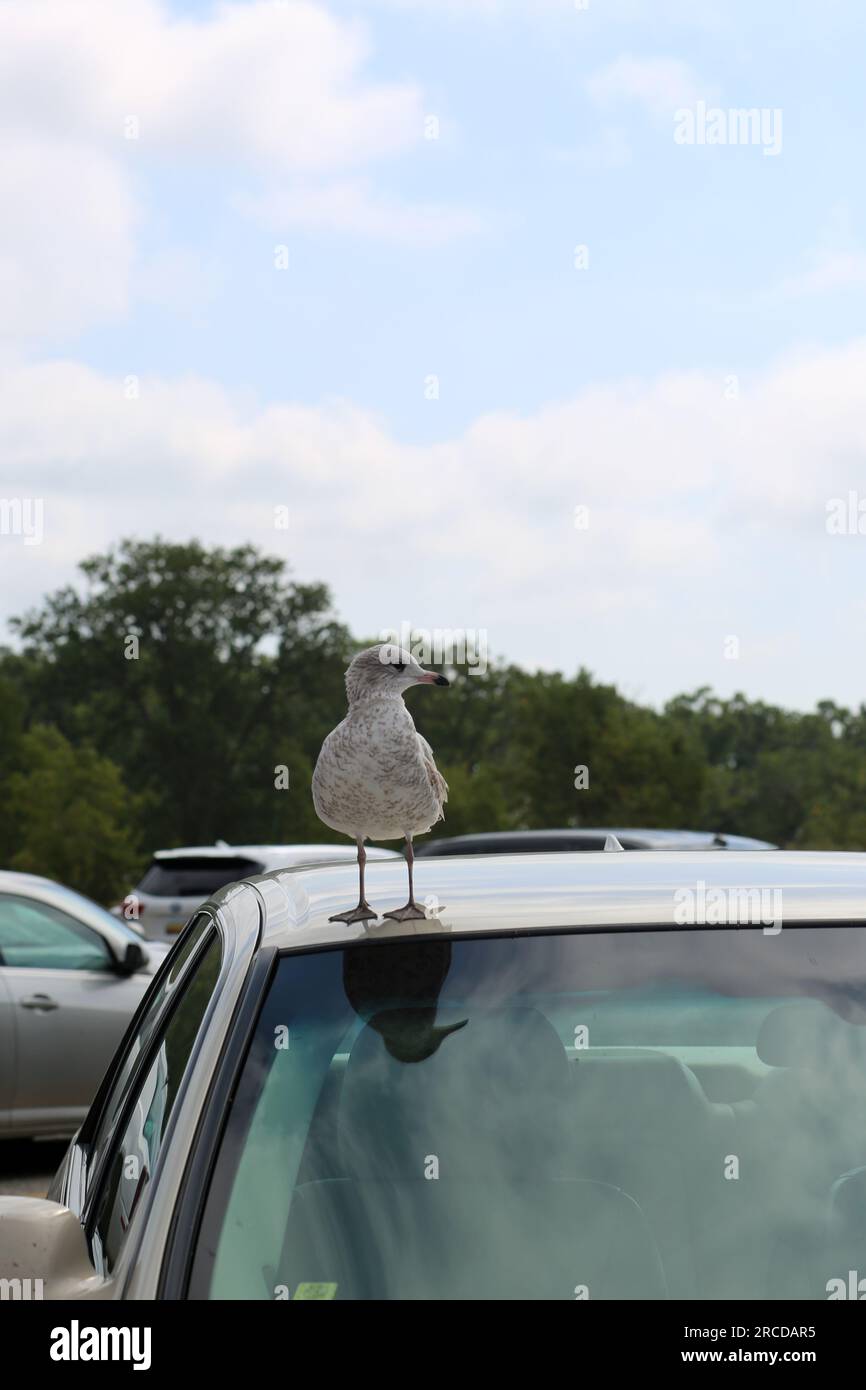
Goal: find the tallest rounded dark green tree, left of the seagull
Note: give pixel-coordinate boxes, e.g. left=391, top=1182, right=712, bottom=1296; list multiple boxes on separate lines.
left=15, top=538, right=349, bottom=849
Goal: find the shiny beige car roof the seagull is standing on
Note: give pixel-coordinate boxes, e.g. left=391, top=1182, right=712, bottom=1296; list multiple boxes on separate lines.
left=211, top=849, right=866, bottom=949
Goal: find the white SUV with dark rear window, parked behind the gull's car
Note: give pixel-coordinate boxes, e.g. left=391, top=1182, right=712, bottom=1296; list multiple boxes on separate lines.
left=118, top=841, right=400, bottom=941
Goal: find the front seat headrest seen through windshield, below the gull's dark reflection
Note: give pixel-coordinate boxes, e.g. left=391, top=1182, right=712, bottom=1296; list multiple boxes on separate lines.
left=339, top=1005, right=569, bottom=1180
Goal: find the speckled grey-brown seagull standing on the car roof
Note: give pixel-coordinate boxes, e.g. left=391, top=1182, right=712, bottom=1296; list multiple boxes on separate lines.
left=313, top=642, right=449, bottom=923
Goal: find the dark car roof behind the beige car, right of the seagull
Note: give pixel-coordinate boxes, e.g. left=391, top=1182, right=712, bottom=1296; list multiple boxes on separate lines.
left=416, top=827, right=777, bottom=858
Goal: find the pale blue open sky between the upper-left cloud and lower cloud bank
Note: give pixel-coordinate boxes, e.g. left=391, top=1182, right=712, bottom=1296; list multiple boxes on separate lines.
left=66, top=3, right=866, bottom=441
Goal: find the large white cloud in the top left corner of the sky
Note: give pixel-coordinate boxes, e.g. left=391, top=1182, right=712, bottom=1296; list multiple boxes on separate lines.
left=0, top=0, right=461, bottom=341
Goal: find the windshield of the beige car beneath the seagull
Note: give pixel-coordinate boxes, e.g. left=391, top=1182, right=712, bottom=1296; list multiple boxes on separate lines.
left=190, top=927, right=866, bottom=1300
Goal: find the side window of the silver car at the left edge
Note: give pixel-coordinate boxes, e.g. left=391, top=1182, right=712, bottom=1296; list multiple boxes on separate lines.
left=0, top=894, right=114, bottom=970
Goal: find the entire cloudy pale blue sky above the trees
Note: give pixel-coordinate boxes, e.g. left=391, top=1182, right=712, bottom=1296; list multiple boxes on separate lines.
left=0, top=0, right=866, bottom=709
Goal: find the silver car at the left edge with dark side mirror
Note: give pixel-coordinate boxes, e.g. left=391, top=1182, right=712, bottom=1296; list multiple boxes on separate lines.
left=0, top=872, right=165, bottom=1138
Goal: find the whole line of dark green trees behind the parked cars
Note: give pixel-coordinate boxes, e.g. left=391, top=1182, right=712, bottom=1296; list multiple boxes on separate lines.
left=0, top=538, right=866, bottom=902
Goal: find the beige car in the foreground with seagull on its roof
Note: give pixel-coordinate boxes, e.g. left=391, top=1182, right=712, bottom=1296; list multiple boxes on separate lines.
left=6, top=851, right=866, bottom=1305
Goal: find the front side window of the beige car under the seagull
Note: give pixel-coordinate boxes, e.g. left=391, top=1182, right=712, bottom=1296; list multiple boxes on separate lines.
left=92, top=934, right=221, bottom=1273
